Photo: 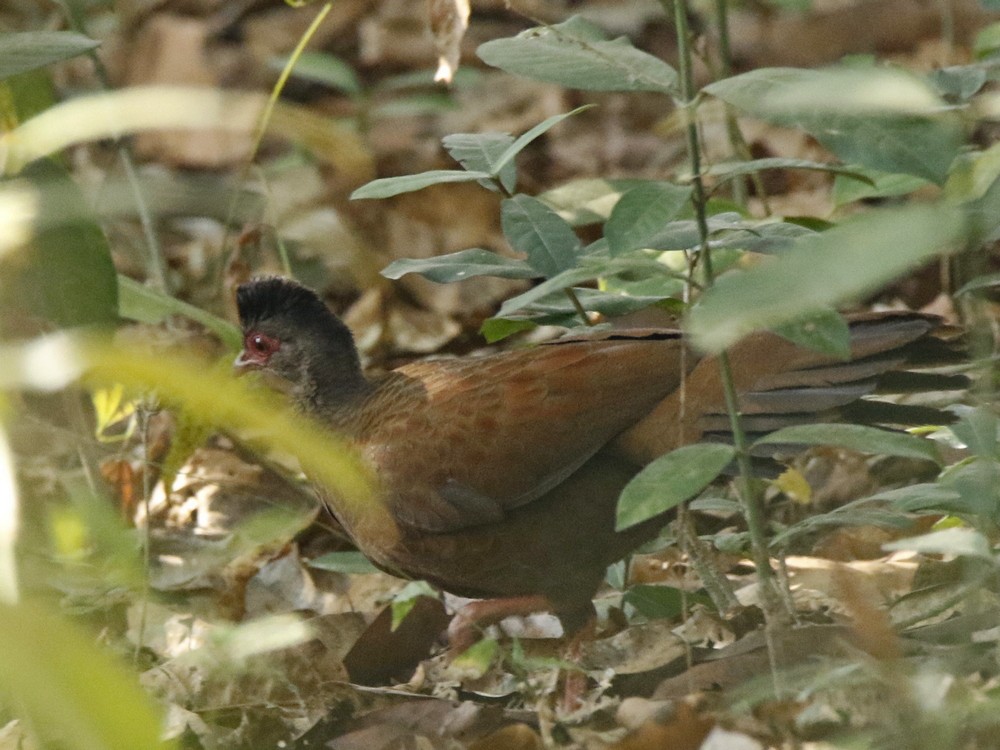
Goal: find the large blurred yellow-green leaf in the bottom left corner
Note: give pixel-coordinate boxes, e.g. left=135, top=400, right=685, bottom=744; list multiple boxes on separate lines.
left=0, top=603, right=172, bottom=750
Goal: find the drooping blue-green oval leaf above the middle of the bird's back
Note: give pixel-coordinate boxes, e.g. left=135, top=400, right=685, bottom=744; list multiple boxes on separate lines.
left=500, top=195, right=581, bottom=277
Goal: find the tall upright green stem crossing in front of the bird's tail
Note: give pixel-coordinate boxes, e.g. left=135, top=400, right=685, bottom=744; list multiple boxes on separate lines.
left=660, top=0, right=780, bottom=621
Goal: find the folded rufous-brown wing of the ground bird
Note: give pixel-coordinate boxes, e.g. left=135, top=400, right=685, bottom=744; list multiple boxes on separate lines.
left=358, top=337, right=694, bottom=532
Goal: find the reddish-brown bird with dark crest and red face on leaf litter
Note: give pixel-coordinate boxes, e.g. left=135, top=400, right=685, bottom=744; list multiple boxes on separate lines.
left=234, top=277, right=956, bottom=646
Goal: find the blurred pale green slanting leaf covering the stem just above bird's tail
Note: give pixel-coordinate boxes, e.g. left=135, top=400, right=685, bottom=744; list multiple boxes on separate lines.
left=687, top=206, right=963, bottom=351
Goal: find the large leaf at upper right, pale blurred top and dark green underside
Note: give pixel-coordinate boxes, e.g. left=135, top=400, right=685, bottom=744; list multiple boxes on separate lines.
left=705, top=67, right=963, bottom=183
